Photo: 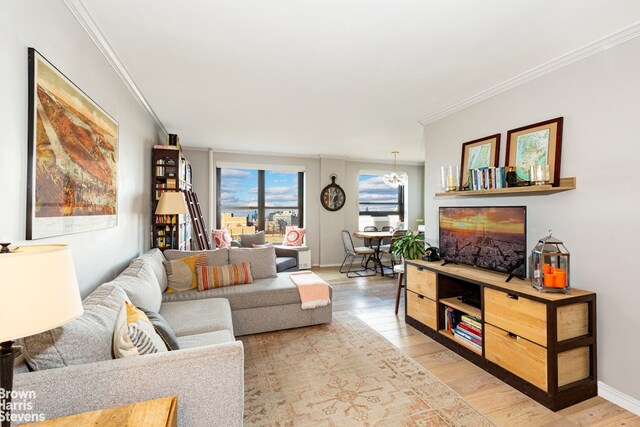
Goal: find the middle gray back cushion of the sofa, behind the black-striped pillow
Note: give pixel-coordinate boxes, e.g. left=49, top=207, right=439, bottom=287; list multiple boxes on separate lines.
left=117, top=258, right=164, bottom=312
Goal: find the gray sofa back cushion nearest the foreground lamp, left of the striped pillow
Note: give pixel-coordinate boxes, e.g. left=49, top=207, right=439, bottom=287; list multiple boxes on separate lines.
left=22, top=283, right=127, bottom=370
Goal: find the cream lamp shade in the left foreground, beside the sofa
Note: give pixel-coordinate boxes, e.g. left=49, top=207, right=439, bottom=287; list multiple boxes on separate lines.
left=0, top=245, right=83, bottom=342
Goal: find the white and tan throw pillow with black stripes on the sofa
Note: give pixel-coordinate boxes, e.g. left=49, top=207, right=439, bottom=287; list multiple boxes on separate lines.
left=113, top=301, right=167, bottom=359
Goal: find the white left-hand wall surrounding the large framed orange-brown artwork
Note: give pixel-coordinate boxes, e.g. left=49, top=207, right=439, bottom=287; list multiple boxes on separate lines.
left=0, top=0, right=158, bottom=295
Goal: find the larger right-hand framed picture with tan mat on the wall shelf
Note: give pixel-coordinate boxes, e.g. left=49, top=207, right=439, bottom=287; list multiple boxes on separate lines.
left=505, top=117, right=564, bottom=187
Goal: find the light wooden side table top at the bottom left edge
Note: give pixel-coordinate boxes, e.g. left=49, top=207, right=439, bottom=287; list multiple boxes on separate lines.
left=24, top=397, right=178, bottom=427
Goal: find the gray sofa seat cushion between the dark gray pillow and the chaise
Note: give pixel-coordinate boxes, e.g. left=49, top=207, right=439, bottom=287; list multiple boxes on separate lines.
left=160, top=298, right=234, bottom=338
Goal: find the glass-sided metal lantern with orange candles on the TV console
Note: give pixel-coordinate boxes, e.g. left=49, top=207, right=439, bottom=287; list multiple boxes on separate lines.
left=529, top=230, right=570, bottom=293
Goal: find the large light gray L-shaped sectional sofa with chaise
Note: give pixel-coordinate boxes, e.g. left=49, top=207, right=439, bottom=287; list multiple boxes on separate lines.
left=14, top=249, right=331, bottom=426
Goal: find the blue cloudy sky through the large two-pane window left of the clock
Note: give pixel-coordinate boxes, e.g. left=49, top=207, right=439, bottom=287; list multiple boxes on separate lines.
left=220, top=169, right=298, bottom=207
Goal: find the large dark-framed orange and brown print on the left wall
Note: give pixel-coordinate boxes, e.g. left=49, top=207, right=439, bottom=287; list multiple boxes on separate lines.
left=27, top=48, right=118, bottom=240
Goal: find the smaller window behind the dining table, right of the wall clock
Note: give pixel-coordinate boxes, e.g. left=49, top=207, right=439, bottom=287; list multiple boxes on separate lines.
left=358, top=175, right=404, bottom=221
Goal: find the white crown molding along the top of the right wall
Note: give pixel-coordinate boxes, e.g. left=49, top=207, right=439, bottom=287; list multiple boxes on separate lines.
left=419, top=22, right=640, bottom=126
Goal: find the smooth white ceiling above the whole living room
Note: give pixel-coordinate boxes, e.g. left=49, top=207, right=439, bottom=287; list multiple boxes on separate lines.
left=77, top=0, right=640, bottom=161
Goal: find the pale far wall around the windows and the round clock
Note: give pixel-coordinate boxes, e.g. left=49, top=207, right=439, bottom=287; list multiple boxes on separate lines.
left=184, top=148, right=424, bottom=266
